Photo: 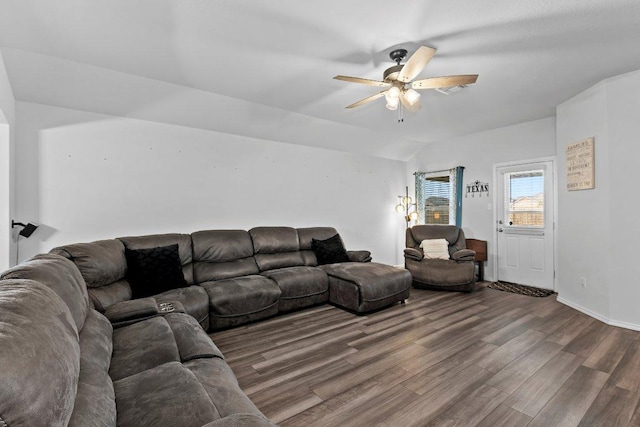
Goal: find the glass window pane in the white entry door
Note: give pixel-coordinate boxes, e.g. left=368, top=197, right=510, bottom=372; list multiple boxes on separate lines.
left=504, top=170, right=544, bottom=228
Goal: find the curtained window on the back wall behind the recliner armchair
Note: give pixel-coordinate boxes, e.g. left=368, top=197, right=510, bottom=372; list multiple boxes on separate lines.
left=415, top=166, right=464, bottom=227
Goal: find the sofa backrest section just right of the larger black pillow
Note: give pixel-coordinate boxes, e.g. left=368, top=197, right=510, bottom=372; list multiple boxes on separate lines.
left=191, top=230, right=259, bottom=283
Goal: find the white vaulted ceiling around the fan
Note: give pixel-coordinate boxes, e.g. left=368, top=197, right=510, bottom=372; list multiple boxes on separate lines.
left=0, top=0, right=640, bottom=159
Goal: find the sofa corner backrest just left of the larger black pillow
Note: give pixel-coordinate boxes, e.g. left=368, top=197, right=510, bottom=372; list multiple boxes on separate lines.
left=50, top=239, right=131, bottom=312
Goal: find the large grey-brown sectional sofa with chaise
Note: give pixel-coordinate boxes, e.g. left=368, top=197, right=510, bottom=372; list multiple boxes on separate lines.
left=0, top=227, right=411, bottom=427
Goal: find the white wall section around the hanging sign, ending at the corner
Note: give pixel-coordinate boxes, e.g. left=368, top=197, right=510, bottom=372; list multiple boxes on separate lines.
left=556, top=80, right=610, bottom=318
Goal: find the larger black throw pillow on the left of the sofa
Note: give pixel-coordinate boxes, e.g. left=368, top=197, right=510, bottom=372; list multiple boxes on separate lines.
left=125, top=244, right=188, bottom=298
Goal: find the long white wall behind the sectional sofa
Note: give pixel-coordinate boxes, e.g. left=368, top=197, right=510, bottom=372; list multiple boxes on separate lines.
left=16, top=102, right=406, bottom=264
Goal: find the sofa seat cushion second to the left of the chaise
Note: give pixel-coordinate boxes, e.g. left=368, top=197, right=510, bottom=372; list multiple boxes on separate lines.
left=201, top=275, right=281, bottom=329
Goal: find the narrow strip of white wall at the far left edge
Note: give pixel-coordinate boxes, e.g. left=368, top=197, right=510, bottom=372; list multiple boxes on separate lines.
left=0, top=52, right=15, bottom=271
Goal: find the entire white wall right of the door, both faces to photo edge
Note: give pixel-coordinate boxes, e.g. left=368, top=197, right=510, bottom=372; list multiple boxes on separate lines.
left=557, top=71, right=640, bottom=330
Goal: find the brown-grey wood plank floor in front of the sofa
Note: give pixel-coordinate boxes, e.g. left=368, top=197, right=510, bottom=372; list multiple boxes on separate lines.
left=211, top=286, right=640, bottom=427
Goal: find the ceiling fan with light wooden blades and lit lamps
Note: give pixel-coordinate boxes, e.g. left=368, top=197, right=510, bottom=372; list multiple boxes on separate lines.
left=334, top=46, right=478, bottom=111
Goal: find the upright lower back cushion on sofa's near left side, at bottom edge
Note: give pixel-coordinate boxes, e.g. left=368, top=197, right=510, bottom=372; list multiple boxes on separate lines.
left=69, top=310, right=116, bottom=427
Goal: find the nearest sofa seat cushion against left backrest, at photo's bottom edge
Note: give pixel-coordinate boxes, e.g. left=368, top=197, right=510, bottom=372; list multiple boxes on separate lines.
left=114, top=362, right=220, bottom=427
